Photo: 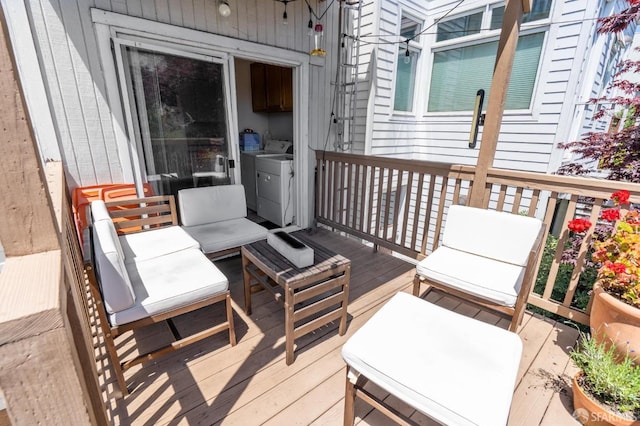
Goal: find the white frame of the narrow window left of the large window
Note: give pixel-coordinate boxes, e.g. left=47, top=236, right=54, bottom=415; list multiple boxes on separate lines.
left=390, top=7, right=425, bottom=117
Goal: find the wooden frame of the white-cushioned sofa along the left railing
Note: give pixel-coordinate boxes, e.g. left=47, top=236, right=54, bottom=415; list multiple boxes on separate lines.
left=84, top=196, right=236, bottom=396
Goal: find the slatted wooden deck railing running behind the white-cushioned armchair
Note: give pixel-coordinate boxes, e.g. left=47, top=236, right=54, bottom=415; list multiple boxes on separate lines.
left=316, top=152, right=640, bottom=324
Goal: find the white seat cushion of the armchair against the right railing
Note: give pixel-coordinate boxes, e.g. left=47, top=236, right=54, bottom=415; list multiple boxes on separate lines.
left=416, top=246, right=526, bottom=307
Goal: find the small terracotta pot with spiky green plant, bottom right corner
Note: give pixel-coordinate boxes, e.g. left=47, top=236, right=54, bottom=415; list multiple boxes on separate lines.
left=569, top=334, right=640, bottom=425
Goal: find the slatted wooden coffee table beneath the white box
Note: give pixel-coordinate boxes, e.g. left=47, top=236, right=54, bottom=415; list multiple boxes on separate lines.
left=242, top=230, right=351, bottom=365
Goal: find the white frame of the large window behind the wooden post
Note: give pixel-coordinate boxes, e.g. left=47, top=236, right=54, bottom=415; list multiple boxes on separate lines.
left=421, top=0, right=557, bottom=121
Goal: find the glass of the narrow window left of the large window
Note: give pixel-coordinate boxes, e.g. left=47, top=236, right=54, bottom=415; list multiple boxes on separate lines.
left=393, top=14, right=422, bottom=112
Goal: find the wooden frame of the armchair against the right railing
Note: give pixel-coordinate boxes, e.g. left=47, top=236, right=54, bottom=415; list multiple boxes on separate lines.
left=413, top=224, right=546, bottom=332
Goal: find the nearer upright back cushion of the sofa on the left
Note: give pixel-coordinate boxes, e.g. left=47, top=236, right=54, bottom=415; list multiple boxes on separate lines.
left=93, top=220, right=135, bottom=314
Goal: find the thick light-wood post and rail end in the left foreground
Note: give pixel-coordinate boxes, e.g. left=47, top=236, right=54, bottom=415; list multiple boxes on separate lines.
left=0, top=9, right=106, bottom=425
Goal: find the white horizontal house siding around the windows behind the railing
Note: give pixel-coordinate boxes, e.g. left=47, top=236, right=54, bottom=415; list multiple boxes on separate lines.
left=354, top=0, right=615, bottom=172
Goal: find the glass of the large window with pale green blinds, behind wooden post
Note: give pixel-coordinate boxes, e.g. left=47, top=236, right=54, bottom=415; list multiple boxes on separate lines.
left=427, top=0, right=551, bottom=112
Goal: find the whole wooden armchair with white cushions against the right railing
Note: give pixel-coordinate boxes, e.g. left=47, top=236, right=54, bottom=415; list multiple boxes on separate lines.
left=413, top=205, right=544, bottom=331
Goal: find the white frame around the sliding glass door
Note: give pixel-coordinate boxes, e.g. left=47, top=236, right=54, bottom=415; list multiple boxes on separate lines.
left=91, top=8, right=312, bottom=228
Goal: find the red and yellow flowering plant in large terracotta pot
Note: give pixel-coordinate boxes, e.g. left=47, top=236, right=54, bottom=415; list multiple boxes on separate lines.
left=569, top=191, right=640, bottom=363
